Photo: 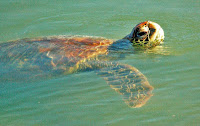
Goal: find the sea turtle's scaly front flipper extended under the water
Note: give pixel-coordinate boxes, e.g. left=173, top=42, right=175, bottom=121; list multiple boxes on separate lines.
left=98, top=63, right=153, bottom=108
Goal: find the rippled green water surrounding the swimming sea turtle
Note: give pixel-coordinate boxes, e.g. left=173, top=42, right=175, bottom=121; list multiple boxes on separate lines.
left=0, top=0, right=200, bottom=126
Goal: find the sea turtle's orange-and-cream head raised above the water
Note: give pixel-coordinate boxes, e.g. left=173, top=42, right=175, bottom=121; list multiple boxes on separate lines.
left=123, top=21, right=164, bottom=44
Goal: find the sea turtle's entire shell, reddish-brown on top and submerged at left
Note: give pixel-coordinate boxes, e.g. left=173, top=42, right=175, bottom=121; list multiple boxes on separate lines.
left=0, top=36, right=113, bottom=80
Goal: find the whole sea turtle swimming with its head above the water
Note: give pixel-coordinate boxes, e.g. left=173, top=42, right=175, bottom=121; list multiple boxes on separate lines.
left=0, top=21, right=164, bottom=108
